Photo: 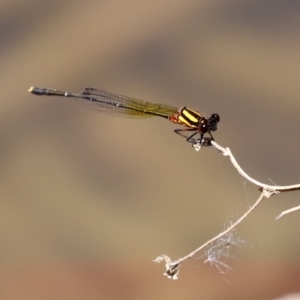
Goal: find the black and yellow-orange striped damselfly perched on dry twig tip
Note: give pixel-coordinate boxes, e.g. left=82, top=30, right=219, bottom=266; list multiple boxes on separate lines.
left=29, top=87, right=220, bottom=146
